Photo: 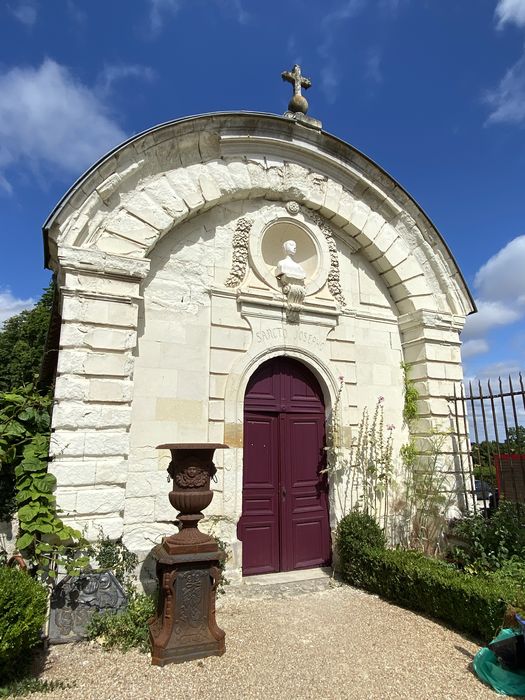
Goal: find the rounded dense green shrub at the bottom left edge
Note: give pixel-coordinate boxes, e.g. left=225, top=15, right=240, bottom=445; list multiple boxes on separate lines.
left=0, top=567, right=47, bottom=683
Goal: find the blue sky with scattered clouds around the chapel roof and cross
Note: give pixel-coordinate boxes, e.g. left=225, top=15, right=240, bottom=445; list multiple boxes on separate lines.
left=0, top=0, right=525, bottom=377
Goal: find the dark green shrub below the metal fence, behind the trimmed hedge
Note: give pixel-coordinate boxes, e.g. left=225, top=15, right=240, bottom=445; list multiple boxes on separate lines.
left=449, top=500, right=525, bottom=573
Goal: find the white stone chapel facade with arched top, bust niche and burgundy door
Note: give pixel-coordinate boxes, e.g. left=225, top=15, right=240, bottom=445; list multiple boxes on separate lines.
left=44, top=113, right=474, bottom=575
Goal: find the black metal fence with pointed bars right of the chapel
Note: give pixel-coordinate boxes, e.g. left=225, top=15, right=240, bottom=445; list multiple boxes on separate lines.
left=451, top=373, right=525, bottom=513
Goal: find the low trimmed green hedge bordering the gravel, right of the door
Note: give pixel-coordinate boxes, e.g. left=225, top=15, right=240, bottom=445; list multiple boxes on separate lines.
left=337, top=513, right=525, bottom=641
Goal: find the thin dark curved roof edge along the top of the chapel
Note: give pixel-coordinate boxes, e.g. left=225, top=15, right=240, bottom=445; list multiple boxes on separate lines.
left=42, top=110, right=477, bottom=313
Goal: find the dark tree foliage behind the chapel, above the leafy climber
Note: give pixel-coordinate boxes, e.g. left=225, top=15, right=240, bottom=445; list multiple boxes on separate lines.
left=0, top=282, right=54, bottom=391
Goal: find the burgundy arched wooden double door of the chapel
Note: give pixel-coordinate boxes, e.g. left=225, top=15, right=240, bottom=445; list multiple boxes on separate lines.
left=238, top=357, right=331, bottom=576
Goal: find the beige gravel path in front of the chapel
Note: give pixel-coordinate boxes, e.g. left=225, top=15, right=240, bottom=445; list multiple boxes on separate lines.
left=23, top=586, right=497, bottom=700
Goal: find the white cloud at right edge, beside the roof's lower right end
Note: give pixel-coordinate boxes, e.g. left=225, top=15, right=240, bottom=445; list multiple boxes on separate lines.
left=474, top=236, right=525, bottom=303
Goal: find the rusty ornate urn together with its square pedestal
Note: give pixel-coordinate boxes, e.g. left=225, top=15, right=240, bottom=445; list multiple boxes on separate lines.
left=149, top=443, right=227, bottom=666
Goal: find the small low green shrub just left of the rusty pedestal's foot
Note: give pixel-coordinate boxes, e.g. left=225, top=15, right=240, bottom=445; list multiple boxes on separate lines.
left=87, top=593, right=155, bottom=652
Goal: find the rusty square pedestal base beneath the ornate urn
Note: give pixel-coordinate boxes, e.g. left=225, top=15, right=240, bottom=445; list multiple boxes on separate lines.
left=149, top=545, right=226, bottom=666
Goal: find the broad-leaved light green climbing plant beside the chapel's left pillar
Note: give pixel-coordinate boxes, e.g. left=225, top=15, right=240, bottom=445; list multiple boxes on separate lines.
left=0, top=385, right=88, bottom=580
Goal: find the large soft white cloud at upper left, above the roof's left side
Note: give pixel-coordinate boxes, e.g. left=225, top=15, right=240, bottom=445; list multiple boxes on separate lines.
left=0, top=59, right=126, bottom=188
